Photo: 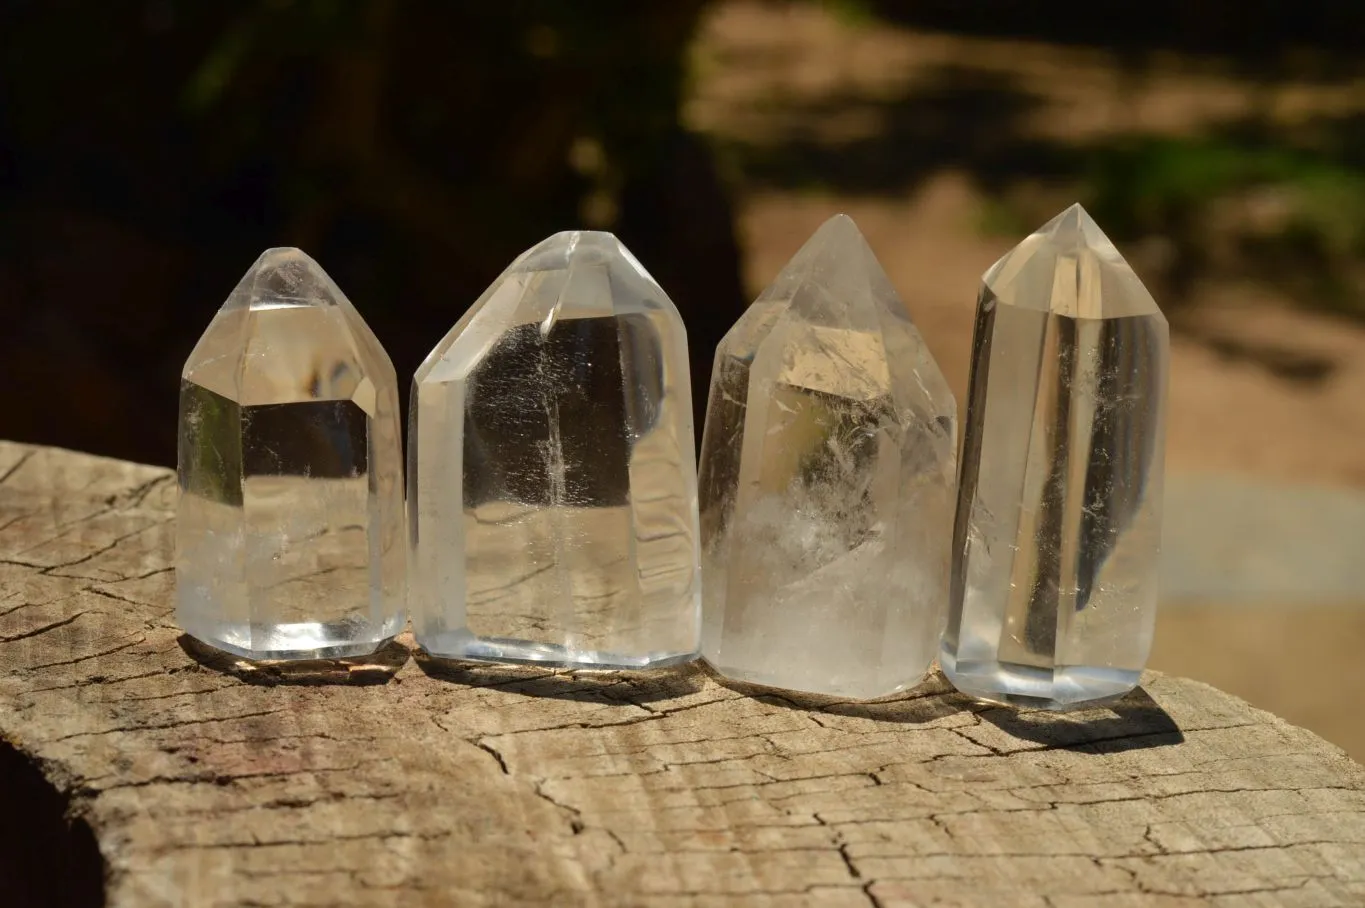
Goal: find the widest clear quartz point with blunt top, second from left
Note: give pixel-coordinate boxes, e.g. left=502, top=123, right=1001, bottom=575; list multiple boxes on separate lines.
left=408, top=231, right=700, bottom=669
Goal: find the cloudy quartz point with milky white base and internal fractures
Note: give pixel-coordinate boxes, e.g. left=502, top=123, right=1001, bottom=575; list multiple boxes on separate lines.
left=700, top=214, right=957, bottom=699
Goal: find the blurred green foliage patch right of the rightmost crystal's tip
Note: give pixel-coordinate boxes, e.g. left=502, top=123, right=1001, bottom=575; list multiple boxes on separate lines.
left=1081, top=123, right=1365, bottom=317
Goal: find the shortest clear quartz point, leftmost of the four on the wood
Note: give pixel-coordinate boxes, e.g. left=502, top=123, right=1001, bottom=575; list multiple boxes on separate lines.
left=176, top=249, right=407, bottom=659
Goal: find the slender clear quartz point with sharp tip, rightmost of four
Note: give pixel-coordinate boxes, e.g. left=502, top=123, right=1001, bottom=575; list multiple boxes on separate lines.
left=940, top=205, right=1170, bottom=709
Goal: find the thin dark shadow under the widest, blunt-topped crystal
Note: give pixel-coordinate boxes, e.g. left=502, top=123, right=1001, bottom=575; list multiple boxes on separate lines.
left=412, top=649, right=706, bottom=706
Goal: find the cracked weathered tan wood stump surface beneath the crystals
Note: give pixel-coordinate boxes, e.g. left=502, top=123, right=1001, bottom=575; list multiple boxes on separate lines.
left=0, top=444, right=1365, bottom=908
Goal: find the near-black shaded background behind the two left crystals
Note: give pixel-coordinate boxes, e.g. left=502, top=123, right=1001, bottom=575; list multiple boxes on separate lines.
left=0, top=0, right=744, bottom=463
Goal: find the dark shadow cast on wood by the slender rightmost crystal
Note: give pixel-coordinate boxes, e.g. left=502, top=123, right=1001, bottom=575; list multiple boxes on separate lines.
left=977, top=687, right=1185, bottom=754
